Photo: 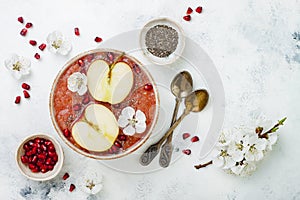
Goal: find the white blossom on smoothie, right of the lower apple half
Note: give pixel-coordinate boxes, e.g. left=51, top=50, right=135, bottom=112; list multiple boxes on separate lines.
left=118, top=106, right=146, bottom=136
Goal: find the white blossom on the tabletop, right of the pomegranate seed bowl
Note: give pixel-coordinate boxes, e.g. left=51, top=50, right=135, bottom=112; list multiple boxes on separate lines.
left=77, top=169, right=103, bottom=194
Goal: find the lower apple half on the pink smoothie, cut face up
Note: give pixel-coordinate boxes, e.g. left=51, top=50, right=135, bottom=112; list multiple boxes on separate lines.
left=72, top=104, right=119, bottom=152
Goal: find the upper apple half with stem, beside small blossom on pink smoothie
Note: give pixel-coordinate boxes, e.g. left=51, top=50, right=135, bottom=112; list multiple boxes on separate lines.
left=87, top=60, right=133, bottom=104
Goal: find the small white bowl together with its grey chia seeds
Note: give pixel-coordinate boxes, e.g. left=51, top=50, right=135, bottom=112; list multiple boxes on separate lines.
left=140, top=18, right=185, bottom=65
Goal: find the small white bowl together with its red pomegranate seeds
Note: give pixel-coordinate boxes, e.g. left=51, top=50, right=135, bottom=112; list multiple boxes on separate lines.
left=16, top=133, right=64, bottom=181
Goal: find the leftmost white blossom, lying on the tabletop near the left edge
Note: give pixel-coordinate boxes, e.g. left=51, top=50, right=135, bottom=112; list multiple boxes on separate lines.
left=4, top=54, right=31, bottom=79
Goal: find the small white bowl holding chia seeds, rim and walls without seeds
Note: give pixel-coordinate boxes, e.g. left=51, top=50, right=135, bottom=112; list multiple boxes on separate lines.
left=140, top=17, right=185, bottom=65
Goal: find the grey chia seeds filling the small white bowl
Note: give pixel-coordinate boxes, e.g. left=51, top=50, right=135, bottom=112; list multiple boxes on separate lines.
left=145, top=25, right=178, bottom=58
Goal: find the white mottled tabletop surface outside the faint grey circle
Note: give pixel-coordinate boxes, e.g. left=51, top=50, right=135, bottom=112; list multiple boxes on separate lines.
left=0, top=0, right=300, bottom=200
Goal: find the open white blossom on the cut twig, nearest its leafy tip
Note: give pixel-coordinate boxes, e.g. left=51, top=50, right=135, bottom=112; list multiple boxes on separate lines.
left=245, top=134, right=267, bottom=161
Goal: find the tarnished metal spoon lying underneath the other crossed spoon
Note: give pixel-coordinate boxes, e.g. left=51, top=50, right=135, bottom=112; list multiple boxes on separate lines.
left=159, top=71, right=193, bottom=167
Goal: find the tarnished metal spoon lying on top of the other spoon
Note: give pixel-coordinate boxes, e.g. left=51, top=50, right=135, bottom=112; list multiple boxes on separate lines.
left=140, top=89, right=209, bottom=166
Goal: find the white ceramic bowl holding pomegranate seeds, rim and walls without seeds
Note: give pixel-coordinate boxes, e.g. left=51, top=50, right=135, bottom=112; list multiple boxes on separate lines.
left=16, top=133, right=64, bottom=181
